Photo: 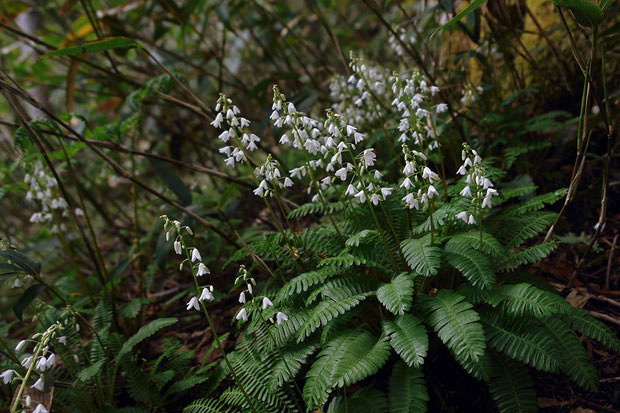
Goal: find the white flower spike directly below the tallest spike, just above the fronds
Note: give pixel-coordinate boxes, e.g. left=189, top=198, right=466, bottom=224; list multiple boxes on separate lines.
left=400, top=144, right=440, bottom=209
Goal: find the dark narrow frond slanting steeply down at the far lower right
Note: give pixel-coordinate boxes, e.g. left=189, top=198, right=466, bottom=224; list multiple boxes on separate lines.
left=545, top=318, right=599, bottom=391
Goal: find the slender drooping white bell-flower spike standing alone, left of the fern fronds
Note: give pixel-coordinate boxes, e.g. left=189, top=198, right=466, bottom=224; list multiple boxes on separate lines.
left=160, top=215, right=214, bottom=311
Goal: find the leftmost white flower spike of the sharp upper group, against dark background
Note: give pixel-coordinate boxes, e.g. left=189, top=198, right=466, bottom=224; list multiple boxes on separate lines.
left=211, top=93, right=260, bottom=167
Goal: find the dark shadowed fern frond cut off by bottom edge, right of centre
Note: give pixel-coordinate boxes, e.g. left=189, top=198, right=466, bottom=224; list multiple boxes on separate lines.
left=489, top=353, right=538, bottom=413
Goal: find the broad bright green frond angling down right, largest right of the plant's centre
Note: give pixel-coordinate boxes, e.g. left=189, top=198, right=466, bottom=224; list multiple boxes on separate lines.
left=419, top=290, right=486, bottom=373
